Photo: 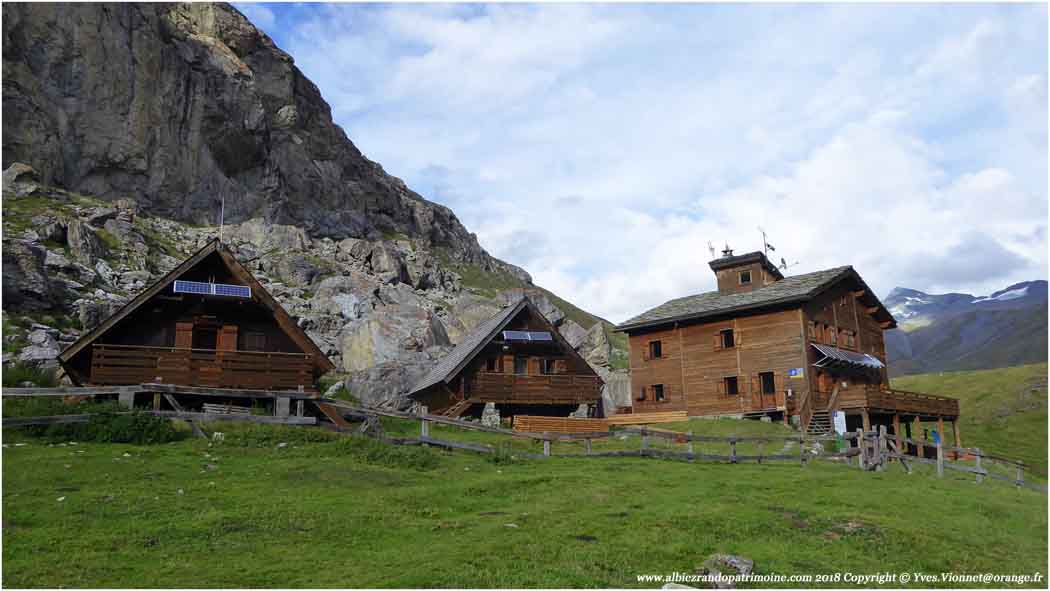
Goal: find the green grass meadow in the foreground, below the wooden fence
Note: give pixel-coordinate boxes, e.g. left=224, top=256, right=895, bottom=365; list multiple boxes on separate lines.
left=2, top=422, right=1047, bottom=588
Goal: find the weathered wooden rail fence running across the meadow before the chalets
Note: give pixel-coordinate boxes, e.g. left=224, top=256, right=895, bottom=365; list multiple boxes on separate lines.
left=2, top=384, right=1047, bottom=492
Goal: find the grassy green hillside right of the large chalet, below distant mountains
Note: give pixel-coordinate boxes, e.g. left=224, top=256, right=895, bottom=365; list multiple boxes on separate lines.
left=893, top=363, right=1047, bottom=478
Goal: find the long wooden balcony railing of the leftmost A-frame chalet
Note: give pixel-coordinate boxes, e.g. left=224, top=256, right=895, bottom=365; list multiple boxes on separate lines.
left=90, top=344, right=313, bottom=391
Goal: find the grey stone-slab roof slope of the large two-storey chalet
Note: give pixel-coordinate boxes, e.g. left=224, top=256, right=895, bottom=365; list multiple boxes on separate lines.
left=616, top=266, right=856, bottom=331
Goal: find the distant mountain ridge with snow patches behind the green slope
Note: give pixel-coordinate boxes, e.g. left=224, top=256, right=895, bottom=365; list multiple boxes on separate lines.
left=885, top=280, right=1047, bottom=375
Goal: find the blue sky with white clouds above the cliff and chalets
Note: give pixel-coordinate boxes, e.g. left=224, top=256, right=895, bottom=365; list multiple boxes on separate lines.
left=235, top=3, right=1048, bottom=322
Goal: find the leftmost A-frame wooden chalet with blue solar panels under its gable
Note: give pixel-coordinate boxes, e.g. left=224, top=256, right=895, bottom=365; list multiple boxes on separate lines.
left=59, top=240, right=334, bottom=392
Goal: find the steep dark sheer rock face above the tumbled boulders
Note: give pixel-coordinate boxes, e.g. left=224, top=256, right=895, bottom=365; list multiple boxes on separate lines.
left=3, top=3, right=512, bottom=278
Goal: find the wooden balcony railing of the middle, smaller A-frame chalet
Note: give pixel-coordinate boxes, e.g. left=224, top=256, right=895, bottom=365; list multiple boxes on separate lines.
left=467, top=372, right=602, bottom=404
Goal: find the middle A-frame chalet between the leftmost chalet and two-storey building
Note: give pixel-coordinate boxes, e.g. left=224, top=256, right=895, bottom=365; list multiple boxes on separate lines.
left=408, top=296, right=604, bottom=417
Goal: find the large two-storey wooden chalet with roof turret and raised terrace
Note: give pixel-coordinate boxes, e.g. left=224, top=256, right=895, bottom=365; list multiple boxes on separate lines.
left=616, top=251, right=959, bottom=449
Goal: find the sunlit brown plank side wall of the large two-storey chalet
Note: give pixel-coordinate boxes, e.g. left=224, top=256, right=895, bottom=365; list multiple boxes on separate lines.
left=629, top=309, right=809, bottom=416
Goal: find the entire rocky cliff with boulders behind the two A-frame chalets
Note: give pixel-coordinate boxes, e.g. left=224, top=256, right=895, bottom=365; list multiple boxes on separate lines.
left=3, top=4, right=627, bottom=411
